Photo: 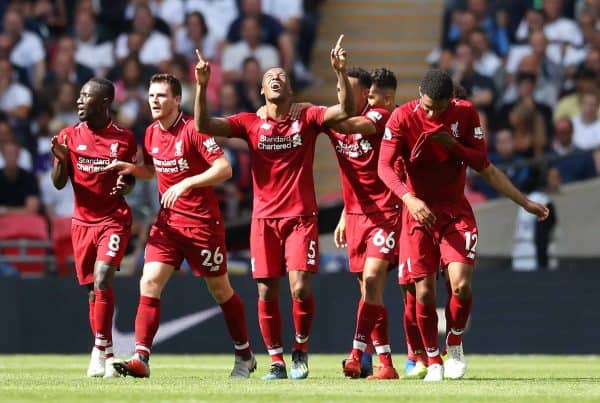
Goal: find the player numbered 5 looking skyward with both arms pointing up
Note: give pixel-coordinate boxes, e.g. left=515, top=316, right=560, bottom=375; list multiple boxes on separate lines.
left=194, top=36, right=355, bottom=380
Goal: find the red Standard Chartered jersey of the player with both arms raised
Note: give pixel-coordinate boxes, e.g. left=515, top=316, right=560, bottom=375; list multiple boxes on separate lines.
left=227, top=106, right=327, bottom=218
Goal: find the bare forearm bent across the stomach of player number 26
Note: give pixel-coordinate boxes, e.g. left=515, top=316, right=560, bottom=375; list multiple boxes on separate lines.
left=160, top=156, right=232, bottom=208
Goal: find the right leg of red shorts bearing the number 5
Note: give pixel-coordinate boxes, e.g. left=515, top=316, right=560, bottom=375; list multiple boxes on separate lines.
left=282, top=217, right=319, bottom=273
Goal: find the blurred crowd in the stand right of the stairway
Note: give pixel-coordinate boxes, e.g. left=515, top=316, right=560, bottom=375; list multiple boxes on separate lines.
left=428, top=0, right=600, bottom=203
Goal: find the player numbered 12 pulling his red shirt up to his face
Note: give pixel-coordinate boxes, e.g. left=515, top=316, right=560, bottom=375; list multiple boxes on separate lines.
left=379, top=70, right=548, bottom=381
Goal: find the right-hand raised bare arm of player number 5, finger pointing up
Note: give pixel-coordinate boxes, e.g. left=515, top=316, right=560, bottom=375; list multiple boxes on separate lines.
left=323, top=34, right=356, bottom=125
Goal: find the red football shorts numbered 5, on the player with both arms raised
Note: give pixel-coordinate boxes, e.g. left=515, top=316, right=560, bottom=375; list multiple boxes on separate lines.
left=250, top=216, right=319, bottom=278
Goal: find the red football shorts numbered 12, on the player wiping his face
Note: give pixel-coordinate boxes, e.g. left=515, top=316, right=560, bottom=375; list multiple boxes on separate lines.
left=398, top=200, right=478, bottom=284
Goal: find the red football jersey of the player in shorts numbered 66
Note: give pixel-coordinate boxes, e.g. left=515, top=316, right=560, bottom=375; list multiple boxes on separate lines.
left=326, top=107, right=400, bottom=214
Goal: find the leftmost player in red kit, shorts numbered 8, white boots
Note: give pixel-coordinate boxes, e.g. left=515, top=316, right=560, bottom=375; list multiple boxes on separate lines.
left=52, top=78, right=136, bottom=378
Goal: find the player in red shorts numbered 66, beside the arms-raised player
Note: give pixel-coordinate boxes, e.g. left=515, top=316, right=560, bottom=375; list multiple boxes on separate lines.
left=326, top=69, right=400, bottom=379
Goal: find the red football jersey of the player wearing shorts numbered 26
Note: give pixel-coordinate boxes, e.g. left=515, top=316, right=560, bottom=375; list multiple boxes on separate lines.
left=144, top=114, right=223, bottom=227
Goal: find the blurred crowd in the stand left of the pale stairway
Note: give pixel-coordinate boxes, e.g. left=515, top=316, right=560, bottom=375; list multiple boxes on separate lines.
left=0, top=0, right=324, bottom=272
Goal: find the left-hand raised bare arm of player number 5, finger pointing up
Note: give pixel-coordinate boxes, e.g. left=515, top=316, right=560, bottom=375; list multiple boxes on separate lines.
left=194, top=49, right=231, bottom=137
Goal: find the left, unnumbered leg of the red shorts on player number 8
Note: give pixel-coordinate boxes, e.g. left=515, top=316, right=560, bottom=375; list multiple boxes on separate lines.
left=71, top=224, right=98, bottom=285
